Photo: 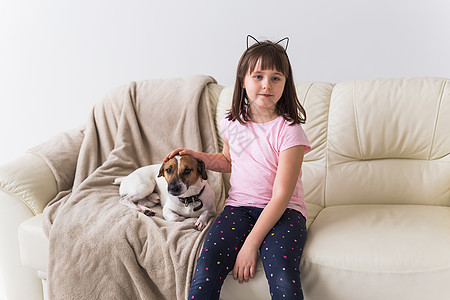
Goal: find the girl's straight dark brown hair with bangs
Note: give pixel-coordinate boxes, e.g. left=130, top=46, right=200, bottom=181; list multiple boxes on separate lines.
left=226, top=41, right=306, bottom=125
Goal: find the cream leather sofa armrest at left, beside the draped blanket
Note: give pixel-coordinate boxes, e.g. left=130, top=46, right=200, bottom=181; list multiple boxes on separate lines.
left=0, top=153, right=57, bottom=299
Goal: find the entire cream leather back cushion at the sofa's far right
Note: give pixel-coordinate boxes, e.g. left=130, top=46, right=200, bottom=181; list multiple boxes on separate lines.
left=325, top=78, right=450, bottom=206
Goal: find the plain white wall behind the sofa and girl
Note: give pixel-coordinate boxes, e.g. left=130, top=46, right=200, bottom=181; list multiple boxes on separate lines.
left=0, top=0, right=450, bottom=163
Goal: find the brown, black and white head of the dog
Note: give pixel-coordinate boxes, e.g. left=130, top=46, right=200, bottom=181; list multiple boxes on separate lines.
left=158, top=155, right=208, bottom=196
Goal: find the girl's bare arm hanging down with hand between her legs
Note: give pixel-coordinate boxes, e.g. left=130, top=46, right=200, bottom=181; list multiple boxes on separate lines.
left=233, top=146, right=305, bottom=283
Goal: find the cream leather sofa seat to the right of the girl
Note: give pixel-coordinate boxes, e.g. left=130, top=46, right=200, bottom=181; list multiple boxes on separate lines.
left=301, top=205, right=450, bottom=300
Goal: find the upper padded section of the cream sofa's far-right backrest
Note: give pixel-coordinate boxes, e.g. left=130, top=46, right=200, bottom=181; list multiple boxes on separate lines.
left=329, top=78, right=450, bottom=161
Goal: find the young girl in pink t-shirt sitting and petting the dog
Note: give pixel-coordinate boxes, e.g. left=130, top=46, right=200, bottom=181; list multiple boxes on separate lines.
left=166, top=36, right=310, bottom=300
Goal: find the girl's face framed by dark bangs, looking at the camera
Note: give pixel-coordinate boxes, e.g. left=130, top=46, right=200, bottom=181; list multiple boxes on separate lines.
left=243, top=61, right=286, bottom=121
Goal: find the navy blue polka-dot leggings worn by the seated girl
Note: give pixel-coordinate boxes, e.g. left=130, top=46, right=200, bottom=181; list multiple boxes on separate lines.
left=188, top=206, right=306, bottom=300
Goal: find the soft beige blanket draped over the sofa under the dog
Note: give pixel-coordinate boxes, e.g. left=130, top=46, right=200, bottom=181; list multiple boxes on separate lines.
left=30, top=76, right=224, bottom=300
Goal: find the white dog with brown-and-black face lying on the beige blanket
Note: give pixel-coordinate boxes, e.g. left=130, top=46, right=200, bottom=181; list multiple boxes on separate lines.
left=114, top=155, right=216, bottom=231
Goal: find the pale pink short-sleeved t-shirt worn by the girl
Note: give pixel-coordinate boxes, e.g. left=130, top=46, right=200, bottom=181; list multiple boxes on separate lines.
left=220, top=117, right=311, bottom=218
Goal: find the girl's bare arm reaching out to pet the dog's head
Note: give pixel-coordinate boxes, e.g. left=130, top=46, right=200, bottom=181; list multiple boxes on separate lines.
left=164, top=138, right=231, bottom=173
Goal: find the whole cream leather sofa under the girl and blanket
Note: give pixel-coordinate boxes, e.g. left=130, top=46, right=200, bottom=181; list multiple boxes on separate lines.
left=0, top=78, right=450, bottom=300
